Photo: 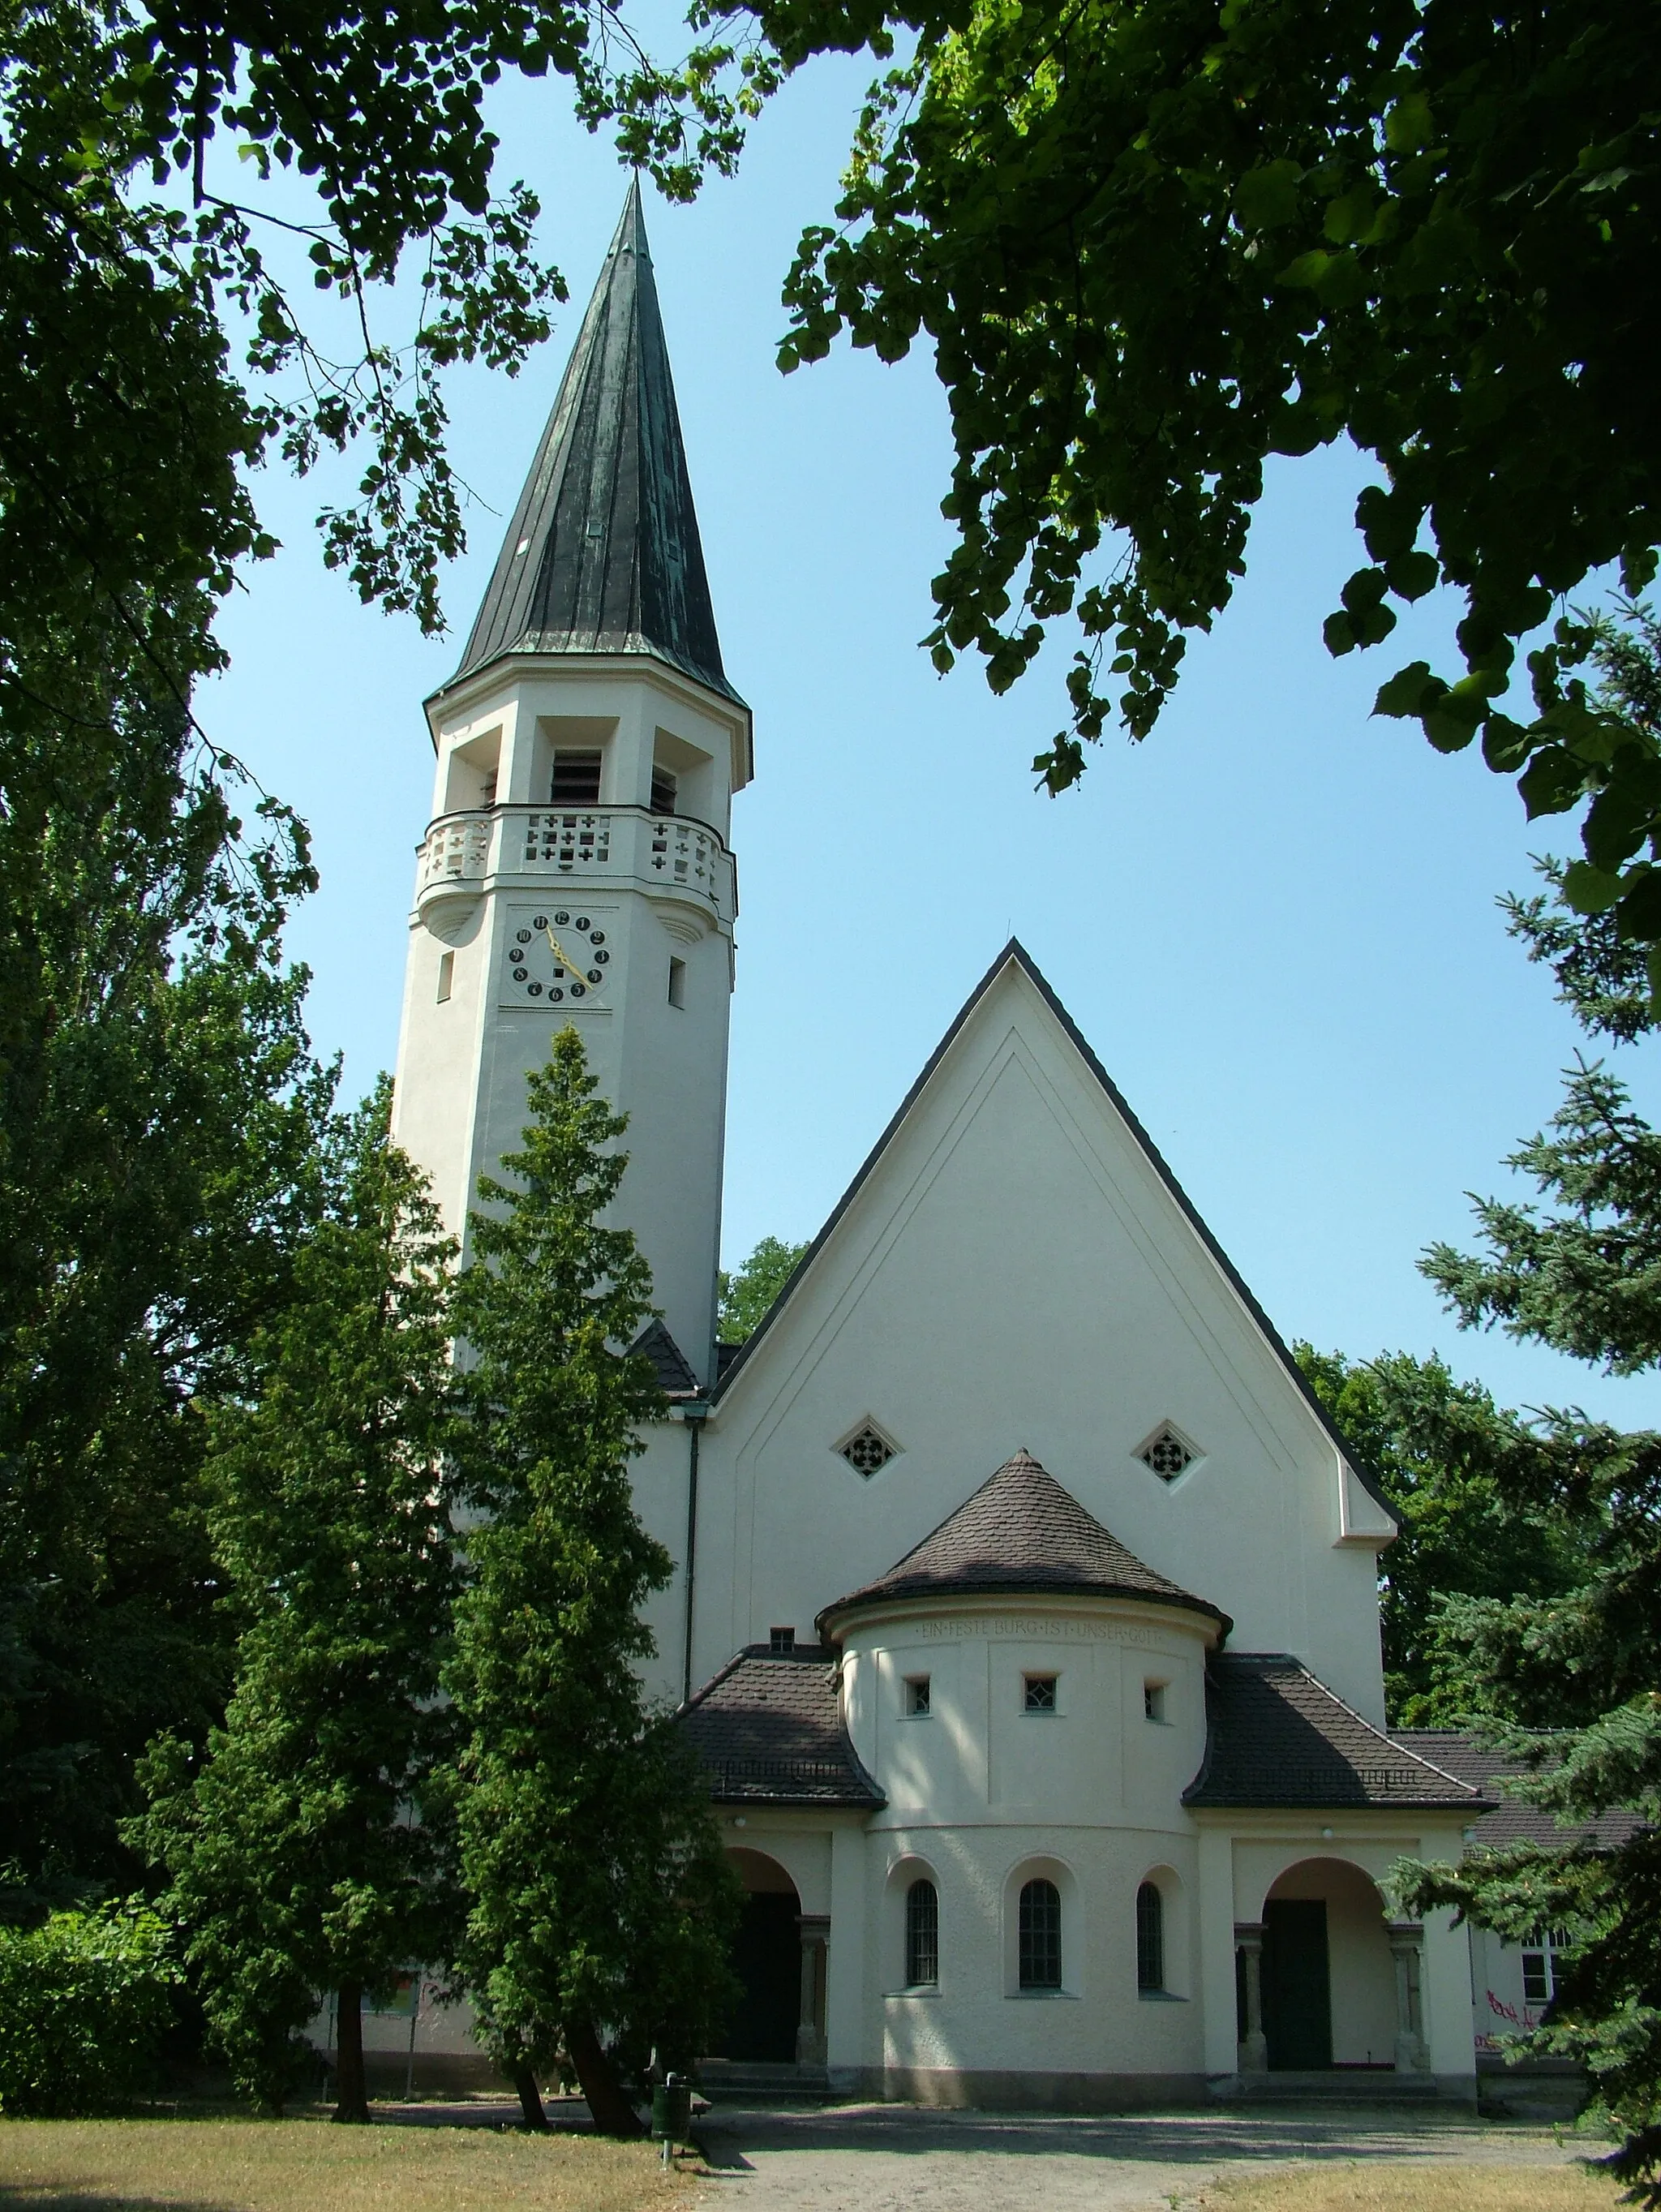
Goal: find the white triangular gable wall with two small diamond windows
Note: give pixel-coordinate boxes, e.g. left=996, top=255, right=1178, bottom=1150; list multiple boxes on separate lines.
left=676, top=962, right=1389, bottom=1725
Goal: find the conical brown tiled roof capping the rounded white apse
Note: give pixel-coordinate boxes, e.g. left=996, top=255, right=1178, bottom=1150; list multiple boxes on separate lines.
left=818, top=1451, right=1230, bottom=1633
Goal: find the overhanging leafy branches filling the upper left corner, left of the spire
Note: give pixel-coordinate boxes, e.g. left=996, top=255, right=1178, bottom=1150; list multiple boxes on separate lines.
left=0, top=0, right=774, bottom=781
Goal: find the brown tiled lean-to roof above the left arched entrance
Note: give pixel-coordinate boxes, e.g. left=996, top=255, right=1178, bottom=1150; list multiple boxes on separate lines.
left=681, top=1643, right=885, bottom=1810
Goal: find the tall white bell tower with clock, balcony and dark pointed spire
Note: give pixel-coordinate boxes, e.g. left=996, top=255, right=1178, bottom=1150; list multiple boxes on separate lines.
left=393, top=182, right=752, bottom=1382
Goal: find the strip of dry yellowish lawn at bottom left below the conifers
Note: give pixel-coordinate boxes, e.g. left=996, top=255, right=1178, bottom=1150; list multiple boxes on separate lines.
left=0, top=2119, right=697, bottom=2212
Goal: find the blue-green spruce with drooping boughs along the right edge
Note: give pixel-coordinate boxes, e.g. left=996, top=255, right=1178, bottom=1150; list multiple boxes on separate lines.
left=1406, top=601, right=1661, bottom=2208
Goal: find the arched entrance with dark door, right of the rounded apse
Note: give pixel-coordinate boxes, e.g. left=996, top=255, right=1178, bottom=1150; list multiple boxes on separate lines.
left=1241, top=1858, right=1422, bottom=2072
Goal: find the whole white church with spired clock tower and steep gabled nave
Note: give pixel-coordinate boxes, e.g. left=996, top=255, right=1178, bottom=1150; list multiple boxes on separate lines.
left=396, top=188, right=1574, bottom=2108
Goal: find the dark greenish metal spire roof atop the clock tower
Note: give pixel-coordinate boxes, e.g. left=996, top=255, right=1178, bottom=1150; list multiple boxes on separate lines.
left=451, top=179, right=743, bottom=703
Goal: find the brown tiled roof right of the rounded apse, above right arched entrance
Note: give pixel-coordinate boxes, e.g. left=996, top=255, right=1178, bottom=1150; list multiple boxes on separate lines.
left=1183, top=1652, right=1482, bottom=1814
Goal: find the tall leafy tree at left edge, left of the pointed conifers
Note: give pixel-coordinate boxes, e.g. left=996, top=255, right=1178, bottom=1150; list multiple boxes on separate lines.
left=0, top=681, right=334, bottom=1918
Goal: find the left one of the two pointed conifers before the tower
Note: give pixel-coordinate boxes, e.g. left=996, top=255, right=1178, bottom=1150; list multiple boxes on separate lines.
left=135, top=1082, right=456, bottom=2121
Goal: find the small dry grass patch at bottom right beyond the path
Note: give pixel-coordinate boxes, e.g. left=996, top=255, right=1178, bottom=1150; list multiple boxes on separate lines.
left=1212, top=2159, right=1621, bottom=2212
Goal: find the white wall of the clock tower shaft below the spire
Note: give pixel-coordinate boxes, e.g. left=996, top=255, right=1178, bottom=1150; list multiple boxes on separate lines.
left=393, top=655, right=749, bottom=1378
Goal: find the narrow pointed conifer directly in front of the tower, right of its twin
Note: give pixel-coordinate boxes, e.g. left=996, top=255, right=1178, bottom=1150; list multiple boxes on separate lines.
left=444, top=1029, right=734, bottom=2135
